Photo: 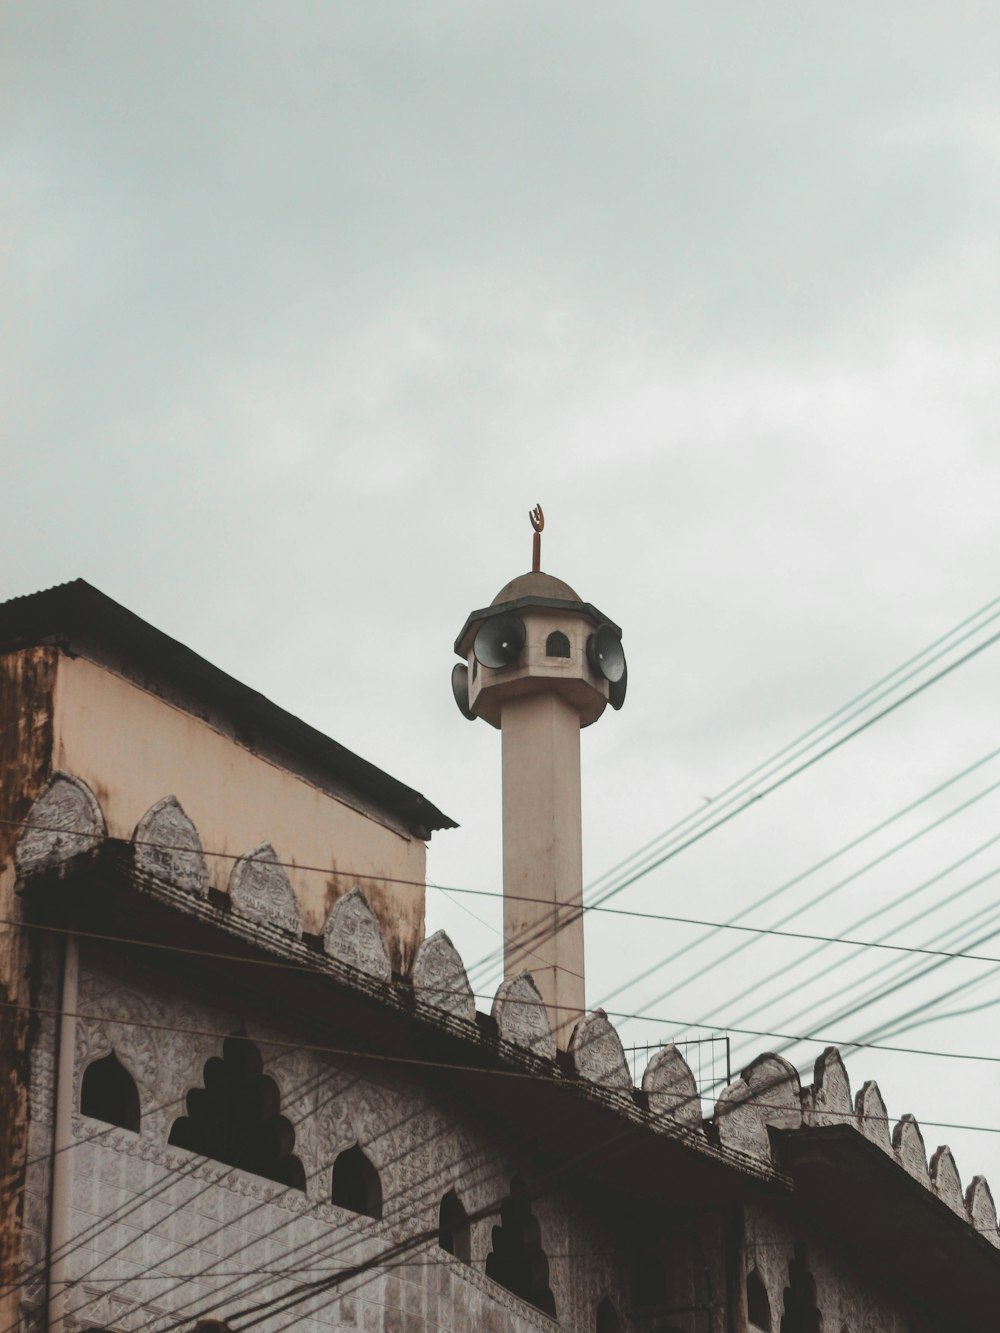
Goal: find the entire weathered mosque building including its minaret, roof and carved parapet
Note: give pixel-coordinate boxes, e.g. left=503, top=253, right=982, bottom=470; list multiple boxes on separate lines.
left=0, top=571, right=1000, bottom=1333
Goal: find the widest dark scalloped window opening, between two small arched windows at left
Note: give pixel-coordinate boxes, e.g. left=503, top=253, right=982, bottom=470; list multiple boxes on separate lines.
left=168, top=1037, right=305, bottom=1189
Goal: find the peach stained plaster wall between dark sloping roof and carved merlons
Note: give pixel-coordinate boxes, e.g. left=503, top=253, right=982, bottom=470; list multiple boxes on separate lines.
left=53, top=656, right=425, bottom=972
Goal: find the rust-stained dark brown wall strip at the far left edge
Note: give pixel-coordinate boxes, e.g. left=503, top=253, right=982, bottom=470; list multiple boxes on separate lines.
left=0, top=648, right=57, bottom=1328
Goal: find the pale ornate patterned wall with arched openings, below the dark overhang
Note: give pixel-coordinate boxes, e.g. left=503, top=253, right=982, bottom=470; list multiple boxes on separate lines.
left=24, top=961, right=650, bottom=1333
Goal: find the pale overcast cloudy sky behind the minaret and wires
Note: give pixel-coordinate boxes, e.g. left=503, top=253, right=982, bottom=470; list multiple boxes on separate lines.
left=0, top=0, right=1000, bottom=1188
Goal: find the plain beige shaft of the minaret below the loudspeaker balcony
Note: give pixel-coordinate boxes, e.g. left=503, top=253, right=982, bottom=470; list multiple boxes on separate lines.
left=500, top=692, right=584, bottom=1046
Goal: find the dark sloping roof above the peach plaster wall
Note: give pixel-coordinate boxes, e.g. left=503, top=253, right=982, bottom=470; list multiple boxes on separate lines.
left=0, top=579, right=457, bottom=838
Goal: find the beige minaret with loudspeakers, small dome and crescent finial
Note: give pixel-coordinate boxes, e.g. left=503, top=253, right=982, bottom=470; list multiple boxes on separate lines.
left=452, top=507, right=627, bottom=1049
